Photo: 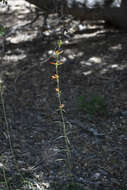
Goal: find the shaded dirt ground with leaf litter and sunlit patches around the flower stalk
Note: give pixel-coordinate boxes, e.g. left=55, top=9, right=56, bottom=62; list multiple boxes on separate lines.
left=0, top=0, right=127, bottom=190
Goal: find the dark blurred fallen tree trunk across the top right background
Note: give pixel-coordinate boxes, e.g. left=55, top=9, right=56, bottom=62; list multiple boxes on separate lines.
left=26, top=0, right=127, bottom=29
